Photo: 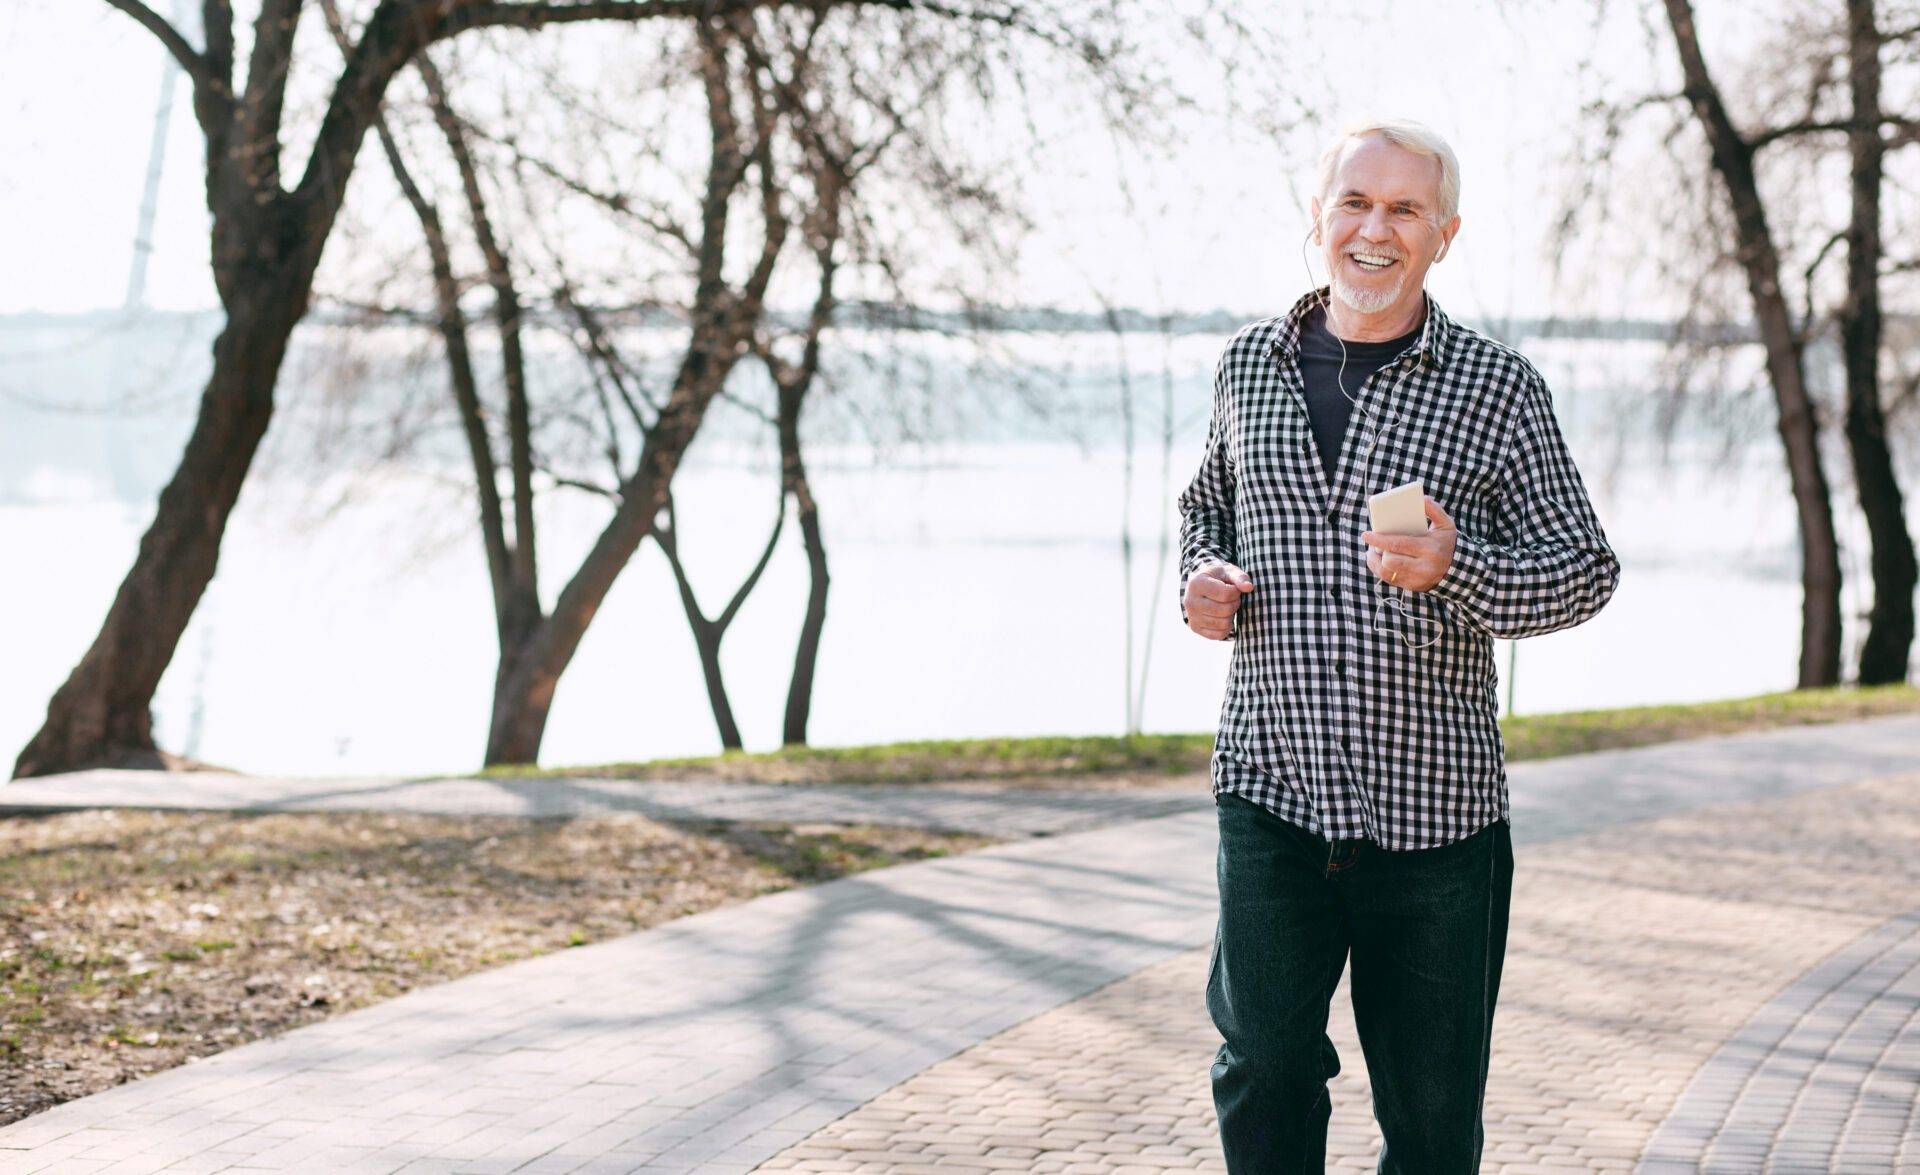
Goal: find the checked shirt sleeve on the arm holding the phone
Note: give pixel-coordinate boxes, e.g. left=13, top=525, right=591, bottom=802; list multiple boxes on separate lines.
left=1428, top=372, right=1620, bottom=639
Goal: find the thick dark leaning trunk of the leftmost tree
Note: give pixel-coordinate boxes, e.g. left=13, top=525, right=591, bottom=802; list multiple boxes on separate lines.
left=13, top=4, right=474, bottom=778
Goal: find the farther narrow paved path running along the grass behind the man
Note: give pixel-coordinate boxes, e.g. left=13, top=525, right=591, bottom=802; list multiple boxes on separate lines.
left=11, top=714, right=1920, bottom=839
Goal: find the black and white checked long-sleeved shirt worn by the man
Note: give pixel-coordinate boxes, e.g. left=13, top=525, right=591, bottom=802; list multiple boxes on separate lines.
left=1179, top=288, right=1620, bottom=851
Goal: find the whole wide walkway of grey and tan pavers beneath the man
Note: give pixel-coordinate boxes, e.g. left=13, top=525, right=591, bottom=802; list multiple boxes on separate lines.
left=0, top=718, right=1920, bottom=1175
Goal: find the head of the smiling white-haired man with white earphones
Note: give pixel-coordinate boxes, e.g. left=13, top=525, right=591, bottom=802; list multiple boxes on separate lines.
left=1313, top=134, right=1459, bottom=338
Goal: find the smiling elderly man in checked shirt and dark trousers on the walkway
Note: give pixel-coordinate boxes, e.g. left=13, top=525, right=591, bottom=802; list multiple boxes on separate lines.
left=1179, top=123, right=1620, bottom=1175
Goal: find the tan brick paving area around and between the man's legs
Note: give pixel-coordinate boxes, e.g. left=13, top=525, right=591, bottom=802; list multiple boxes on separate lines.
left=756, top=774, right=1920, bottom=1175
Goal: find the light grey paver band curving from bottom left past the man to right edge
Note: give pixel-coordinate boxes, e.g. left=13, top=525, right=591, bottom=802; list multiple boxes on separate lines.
left=0, top=716, right=1920, bottom=1175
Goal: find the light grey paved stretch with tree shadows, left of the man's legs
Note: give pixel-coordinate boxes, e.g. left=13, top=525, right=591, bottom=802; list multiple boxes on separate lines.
left=0, top=798, right=1213, bottom=1171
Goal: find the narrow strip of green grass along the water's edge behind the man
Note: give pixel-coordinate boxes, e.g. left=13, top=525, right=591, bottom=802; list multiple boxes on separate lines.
left=480, top=685, right=1920, bottom=783
